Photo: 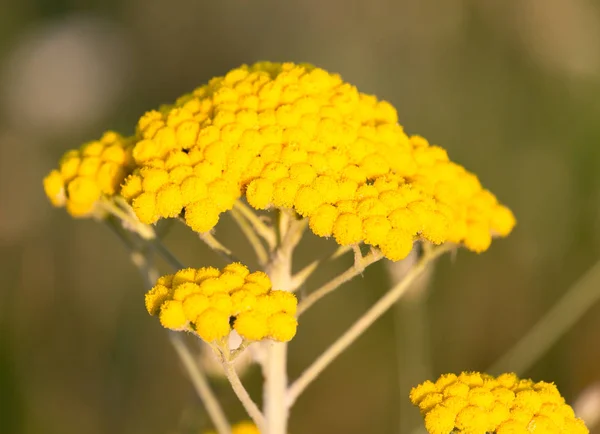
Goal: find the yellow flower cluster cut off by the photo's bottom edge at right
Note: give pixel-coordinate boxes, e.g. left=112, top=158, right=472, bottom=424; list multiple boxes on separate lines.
left=410, top=372, right=589, bottom=434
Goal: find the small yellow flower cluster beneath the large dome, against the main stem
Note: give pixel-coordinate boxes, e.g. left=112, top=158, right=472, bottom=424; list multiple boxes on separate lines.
left=146, top=262, right=298, bottom=342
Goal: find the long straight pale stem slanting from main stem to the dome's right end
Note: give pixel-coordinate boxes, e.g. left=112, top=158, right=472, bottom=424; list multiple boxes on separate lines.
left=286, top=246, right=448, bottom=407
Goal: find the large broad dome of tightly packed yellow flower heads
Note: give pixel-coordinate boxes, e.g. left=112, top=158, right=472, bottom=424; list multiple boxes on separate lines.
left=44, top=62, right=515, bottom=260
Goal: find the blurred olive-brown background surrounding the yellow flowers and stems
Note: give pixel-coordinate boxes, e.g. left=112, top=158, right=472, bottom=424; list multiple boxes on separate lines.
left=0, top=0, right=600, bottom=434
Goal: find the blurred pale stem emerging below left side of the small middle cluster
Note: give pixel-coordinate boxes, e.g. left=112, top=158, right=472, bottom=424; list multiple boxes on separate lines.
left=169, top=332, right=231, bottom=434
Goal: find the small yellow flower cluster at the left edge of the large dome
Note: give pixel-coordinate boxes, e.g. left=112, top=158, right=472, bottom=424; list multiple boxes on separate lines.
left=44, top=131, right=132, bottom=217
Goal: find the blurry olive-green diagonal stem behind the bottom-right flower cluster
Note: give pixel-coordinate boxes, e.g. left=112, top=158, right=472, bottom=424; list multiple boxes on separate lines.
left=486, top=261, right=600, bottom=373
